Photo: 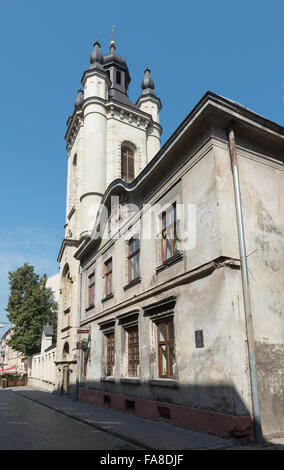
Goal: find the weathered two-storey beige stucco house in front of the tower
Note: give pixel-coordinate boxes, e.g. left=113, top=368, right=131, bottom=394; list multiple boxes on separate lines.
left=75, top=92, right=284, bottom=439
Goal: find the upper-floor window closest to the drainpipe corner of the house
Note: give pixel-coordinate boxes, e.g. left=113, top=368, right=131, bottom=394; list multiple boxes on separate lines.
left=161, top=203, right=178, bottom=263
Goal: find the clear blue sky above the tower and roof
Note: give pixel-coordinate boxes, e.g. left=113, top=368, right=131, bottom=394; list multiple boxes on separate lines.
left=0, top=0, right=284, bottom=333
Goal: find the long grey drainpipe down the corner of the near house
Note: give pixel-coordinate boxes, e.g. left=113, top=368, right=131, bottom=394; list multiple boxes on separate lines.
left=228, top=127, right=263, bottom=444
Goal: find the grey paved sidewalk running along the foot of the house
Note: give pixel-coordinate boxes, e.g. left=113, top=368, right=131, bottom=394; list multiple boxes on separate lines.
left=6, top=387, right=284, bottom=450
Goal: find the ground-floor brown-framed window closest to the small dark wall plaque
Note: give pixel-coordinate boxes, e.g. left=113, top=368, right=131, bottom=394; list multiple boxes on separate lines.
left=157, top=318, right=175, bottom=378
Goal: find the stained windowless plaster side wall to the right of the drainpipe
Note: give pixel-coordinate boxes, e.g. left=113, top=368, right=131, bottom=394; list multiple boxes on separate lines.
left=238, top=149, right=284, bottom=434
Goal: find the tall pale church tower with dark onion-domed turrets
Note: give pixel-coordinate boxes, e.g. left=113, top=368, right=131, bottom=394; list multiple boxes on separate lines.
left=56, top=41, right=161, bottom=394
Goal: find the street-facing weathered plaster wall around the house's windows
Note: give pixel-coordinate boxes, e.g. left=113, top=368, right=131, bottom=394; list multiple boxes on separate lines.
left=79, top=142, right=251, bottom=415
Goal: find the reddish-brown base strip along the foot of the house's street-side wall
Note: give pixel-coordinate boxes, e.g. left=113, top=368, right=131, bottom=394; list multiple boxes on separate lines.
left=78, top=387, right=255, bottom=442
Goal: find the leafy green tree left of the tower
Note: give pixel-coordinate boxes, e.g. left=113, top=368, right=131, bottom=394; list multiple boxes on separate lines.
left=6, top=263, right=57, bottom=357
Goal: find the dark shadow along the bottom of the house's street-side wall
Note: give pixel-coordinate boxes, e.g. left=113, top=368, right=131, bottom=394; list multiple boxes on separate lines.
left=75, top=379, right=254, bottom=442
